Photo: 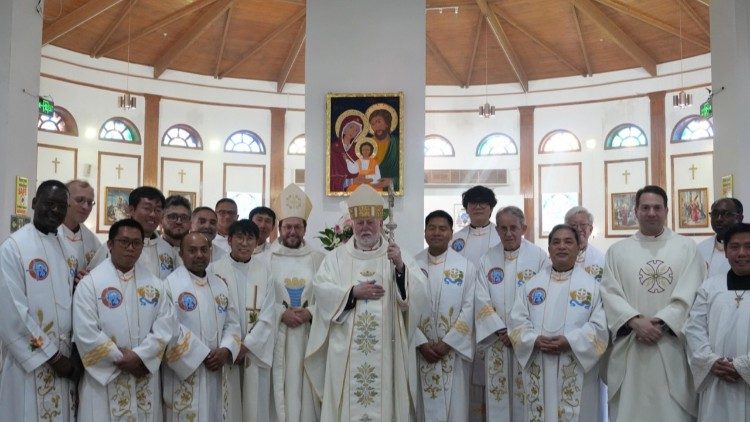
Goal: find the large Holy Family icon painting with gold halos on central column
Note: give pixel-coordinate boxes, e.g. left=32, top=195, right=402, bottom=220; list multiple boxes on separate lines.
left=325, top=92, right=404, bottom=196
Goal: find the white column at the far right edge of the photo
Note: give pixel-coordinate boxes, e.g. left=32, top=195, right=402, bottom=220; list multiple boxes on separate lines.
left=711, top=0, right=750, bottom=204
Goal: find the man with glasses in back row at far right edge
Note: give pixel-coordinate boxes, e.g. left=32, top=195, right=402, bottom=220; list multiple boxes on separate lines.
left=698, top=198, right=743, bottom=277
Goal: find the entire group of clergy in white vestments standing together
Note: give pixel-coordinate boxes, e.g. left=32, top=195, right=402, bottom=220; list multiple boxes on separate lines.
left=0, top=180, right=750, bottom=422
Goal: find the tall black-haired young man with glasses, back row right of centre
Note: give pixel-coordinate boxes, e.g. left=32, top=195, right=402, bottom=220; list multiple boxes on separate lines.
left=451, top=185, right=500, bottom=422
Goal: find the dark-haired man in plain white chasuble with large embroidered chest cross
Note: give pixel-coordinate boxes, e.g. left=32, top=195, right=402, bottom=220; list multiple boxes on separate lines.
left=601, top=185, right=705, bottom=422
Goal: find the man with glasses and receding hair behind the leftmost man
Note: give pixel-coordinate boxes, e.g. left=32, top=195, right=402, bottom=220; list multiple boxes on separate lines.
left=57, top=180, right=102, bottom=271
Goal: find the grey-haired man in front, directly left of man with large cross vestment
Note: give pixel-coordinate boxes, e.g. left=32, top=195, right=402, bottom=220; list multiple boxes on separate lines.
left=510, top=224, right=609, bottom=422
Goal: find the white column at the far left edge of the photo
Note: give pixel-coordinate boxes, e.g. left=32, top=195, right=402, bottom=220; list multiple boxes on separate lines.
left=0, top=0, right=44, bottom=240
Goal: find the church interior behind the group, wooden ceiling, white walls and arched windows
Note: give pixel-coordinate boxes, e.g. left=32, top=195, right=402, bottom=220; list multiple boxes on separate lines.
left=0, top=0, right=750, bottom=253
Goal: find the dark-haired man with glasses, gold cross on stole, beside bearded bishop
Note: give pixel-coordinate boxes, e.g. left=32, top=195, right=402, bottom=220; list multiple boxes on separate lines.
left=211, top=219, right=277, bottom=422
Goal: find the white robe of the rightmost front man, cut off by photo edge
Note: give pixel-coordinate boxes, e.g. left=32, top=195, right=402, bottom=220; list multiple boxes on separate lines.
left=685, top=274, right=750, bottom=421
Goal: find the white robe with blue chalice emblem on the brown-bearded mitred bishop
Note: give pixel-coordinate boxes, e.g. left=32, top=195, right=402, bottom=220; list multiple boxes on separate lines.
left=269, top=242, right=325, bottom=422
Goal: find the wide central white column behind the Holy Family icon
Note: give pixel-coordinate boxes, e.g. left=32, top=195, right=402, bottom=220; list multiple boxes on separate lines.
left=305, top=0, right=426, bottom=255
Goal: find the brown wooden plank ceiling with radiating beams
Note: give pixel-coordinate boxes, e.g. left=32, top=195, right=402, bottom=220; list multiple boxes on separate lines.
left=42, top=0, right=711, bottom=92
